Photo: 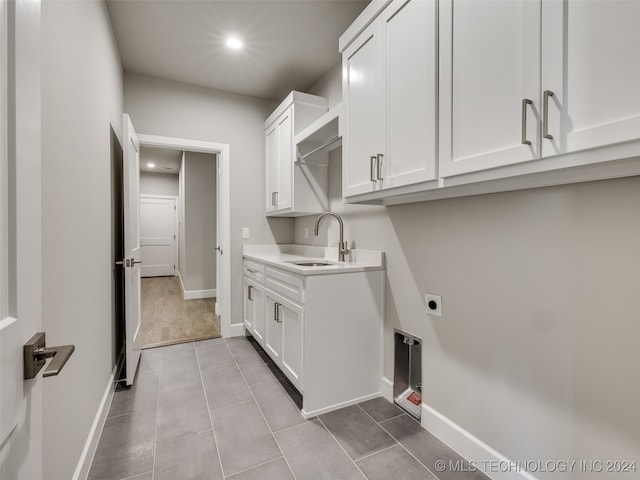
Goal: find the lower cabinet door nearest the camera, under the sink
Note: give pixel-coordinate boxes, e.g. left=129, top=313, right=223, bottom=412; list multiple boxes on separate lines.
left=279, top=300, right=304, bottom=392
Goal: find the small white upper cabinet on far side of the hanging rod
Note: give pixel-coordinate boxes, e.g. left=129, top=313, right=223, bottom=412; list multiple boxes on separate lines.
left=265, top=92, right=329, bottom=216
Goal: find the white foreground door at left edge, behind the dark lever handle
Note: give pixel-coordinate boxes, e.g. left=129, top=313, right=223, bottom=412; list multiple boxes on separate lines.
left=0, top=0, right=43, bottom=480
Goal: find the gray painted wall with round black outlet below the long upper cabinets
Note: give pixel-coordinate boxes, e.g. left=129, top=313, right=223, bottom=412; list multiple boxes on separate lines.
left=295, top=65, right=640, bottom=470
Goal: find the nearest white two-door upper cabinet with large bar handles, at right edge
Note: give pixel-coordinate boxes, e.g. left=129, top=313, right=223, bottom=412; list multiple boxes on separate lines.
left=440, top=0, right=640, bottom=177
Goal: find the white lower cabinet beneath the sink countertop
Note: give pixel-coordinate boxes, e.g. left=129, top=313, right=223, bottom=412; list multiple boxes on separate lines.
left=244, top=259, right=384, bottom=417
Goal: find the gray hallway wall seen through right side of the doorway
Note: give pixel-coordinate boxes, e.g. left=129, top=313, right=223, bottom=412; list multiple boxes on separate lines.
left=180, top=152, right=217, bottom=291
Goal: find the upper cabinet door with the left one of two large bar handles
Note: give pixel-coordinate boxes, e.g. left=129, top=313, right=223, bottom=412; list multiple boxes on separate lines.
left=439, top=0, right=540, bottom=177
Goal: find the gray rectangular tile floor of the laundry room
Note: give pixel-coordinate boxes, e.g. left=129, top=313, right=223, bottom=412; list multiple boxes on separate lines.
left=89, top=338, right=487, bottom=480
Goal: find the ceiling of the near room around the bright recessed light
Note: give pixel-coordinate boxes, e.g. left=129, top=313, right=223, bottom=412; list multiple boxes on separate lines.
left=107, top=0, right=369, bottom=100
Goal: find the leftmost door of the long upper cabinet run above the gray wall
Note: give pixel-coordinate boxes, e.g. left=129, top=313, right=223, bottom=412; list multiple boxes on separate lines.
left=342, top=22, right=386, bottom=197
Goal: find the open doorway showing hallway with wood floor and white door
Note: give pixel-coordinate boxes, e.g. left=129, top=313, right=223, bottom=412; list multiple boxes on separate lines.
left=139, top=145, right=221, bottom=348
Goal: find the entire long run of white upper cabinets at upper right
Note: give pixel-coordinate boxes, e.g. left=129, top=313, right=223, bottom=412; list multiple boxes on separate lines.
left=340, top=0, right=640, bottom=205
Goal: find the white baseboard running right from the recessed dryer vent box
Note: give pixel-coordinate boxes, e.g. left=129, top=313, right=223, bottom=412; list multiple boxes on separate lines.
left=420, top=402, right=536, bottom=480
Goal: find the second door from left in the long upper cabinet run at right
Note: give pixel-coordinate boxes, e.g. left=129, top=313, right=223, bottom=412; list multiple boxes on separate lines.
left=378, top=0, right=438, bottom=189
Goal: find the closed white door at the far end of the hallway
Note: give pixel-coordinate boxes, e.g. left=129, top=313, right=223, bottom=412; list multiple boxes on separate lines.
left=140, top=195, right=178, bottom=277
